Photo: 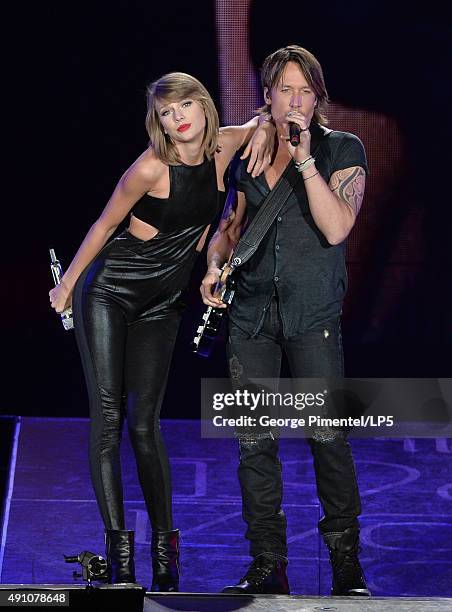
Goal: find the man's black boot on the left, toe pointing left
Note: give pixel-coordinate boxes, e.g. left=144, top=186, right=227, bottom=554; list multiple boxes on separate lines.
left=221, top=553, right=290, bottom=595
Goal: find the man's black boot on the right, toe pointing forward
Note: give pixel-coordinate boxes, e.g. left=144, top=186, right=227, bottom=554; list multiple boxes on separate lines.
left=323, top=527, right=370, bottom=597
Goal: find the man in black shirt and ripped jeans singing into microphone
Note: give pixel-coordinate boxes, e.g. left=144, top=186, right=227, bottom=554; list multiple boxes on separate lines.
left=201, top=45, right=370, bottom=596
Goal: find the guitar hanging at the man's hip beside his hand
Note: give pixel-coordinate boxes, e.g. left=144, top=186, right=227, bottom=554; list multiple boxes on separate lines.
left=192, top=261, right=236, bottom=357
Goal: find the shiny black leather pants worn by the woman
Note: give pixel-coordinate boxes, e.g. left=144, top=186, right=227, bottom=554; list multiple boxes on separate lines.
left=73, top=234, right=190, bottom=531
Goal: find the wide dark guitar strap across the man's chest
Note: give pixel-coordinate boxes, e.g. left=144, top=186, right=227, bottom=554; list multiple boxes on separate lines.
left=231, top=161, right=300, bottom=268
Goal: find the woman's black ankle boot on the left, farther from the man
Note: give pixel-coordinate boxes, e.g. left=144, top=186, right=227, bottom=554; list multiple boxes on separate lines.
left=105, top=529, right=135, bottom=584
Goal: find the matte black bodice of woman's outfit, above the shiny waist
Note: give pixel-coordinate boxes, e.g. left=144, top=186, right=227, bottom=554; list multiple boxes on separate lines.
left=131, top=159, right=222, bottom=233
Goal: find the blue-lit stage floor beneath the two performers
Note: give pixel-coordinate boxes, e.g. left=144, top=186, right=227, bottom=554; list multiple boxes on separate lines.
left=0, top=418, right=452, bottom=596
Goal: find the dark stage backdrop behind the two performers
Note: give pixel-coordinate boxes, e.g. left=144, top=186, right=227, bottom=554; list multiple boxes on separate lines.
left=1, top=0, right=452, bottom=418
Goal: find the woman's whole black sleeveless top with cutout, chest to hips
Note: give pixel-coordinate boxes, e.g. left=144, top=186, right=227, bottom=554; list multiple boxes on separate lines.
left=80, top=159, right=225, bottom=322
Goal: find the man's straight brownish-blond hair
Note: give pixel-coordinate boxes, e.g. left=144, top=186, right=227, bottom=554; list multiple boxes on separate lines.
left=258, top=45, right=328, bottom=125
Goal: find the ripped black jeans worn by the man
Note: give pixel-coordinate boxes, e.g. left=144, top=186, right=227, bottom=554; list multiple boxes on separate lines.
left=228, top=297, right=361, bottom=557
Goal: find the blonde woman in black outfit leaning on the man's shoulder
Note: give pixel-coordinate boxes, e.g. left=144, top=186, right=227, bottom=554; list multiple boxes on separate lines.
left=49, top=72, right=274, bottom=591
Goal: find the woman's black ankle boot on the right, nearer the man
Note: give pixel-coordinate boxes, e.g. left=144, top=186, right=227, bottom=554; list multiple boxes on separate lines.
left=151, top=529, right=180, bottom=592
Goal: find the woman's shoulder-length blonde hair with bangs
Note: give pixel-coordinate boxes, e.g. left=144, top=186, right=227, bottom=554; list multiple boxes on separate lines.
left=146, top=72, right=220, bottom=166
